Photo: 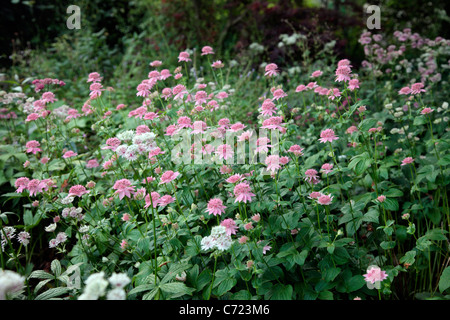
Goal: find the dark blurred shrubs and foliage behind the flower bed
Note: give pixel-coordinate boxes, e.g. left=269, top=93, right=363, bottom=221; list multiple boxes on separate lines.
left=0, top=0, right=450, bottom=99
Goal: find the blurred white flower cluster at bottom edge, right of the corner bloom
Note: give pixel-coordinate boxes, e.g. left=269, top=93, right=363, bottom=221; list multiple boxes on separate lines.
left=78, top=271, right=131, bottom=300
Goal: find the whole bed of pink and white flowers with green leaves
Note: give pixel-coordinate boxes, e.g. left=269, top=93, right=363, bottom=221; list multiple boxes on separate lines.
left=0, top=30, right=450, bottom=300
